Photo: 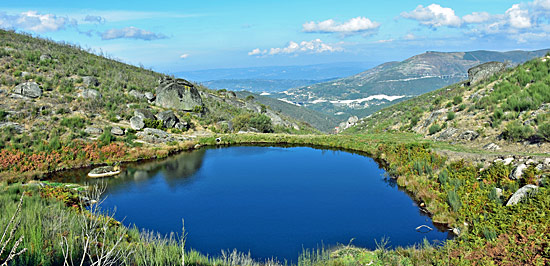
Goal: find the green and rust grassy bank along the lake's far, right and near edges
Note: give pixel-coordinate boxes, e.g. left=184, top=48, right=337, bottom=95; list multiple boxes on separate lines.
left=0, top=134, right=550, bottom=265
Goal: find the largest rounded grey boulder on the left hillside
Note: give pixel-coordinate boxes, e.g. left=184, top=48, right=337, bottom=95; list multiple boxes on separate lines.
left=155, top=78, right=202, bottom=111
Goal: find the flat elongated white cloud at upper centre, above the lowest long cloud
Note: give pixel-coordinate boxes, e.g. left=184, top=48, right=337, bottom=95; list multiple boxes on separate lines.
left=302, top=17, right=380, bottom=34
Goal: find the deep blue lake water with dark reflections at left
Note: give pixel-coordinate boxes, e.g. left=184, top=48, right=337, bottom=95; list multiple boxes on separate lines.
left=66, top=146, right=450, bottom=262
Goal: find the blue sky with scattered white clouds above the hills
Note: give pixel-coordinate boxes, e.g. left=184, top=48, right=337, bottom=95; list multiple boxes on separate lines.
left=0, top=0, right=550, bottom=73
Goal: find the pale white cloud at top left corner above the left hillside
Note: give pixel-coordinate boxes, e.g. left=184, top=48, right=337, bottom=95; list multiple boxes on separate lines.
left=0, top=11, right=73, bottom=32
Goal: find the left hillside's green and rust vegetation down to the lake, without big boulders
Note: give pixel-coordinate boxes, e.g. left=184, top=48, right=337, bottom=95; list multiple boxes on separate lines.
left=0, top=30, right=316, bottom=177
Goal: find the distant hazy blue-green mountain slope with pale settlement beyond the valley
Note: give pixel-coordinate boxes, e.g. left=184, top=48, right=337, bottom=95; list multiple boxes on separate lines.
left=280, top=50, right=548, bottom=120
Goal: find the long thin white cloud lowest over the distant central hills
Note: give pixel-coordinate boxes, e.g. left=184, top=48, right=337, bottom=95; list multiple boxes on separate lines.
left=248, top=39, right=344, bottom=56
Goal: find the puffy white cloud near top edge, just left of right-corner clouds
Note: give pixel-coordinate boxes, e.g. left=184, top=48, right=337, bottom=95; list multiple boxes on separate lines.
left=401, top=4, right=462, bottom=27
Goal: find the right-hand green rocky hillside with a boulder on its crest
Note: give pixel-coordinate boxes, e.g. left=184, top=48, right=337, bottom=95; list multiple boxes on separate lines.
left=346, top=56, right=550, bottom=153
